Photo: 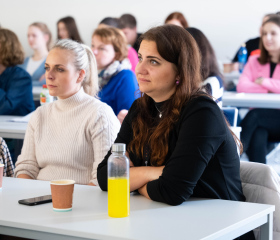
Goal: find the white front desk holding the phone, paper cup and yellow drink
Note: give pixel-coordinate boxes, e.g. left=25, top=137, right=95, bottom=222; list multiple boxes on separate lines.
left=0, top=178, right=275, bottom=240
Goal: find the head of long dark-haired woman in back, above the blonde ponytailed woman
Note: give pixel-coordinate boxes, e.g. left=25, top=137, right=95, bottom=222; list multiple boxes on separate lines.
left=57, top=17, right=83, bottom=43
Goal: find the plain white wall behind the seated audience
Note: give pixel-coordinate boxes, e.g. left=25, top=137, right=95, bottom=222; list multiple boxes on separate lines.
left=0, top=0, right=280, bottom=62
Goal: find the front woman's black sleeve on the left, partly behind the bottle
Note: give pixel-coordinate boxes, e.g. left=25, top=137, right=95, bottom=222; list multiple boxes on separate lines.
left=97, top=101, right=136, bottom=191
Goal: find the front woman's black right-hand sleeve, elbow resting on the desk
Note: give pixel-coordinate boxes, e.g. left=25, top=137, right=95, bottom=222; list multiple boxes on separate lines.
left=147, top=101, right=226, bottom=205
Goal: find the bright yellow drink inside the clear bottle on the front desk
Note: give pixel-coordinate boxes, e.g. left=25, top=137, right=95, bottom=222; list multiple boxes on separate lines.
left=108, top=177, right=130, bottom=218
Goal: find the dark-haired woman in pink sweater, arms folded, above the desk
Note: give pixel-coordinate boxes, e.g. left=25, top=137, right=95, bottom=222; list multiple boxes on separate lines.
left=236, top=15, right=280, bottom=93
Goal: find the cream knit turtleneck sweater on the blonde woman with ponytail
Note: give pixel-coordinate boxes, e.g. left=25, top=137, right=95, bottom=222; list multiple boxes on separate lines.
left=15, top=88, right=120, bottom=185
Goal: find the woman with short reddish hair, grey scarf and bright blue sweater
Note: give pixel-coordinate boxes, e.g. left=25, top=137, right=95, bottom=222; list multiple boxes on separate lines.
left=91, top=27, right=138, bottom=123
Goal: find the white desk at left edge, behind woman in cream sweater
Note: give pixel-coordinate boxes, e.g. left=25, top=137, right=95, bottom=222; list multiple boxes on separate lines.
left=0, top=115, right=28, bottom=139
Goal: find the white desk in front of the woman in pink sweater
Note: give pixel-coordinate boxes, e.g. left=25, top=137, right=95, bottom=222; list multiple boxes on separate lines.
left=223, top=92, right=280, bottom=108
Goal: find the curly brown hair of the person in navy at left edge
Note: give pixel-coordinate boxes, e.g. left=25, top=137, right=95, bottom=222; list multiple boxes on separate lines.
left=0, top=28, right=24, bottom=67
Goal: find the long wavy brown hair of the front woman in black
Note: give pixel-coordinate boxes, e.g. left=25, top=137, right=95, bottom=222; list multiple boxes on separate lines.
left=128, top=25, right=202, bottom=166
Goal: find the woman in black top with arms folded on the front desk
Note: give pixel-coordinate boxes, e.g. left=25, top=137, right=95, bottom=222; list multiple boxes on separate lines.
left=97, top=25, right=254, bottom=239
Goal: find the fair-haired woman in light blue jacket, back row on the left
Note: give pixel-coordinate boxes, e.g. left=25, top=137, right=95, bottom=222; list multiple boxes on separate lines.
left=20, top=22, right=52, bottom=86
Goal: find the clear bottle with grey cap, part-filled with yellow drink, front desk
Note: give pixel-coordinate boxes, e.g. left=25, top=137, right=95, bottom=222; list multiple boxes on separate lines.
left=108, top=143, right=130, bottom=218
